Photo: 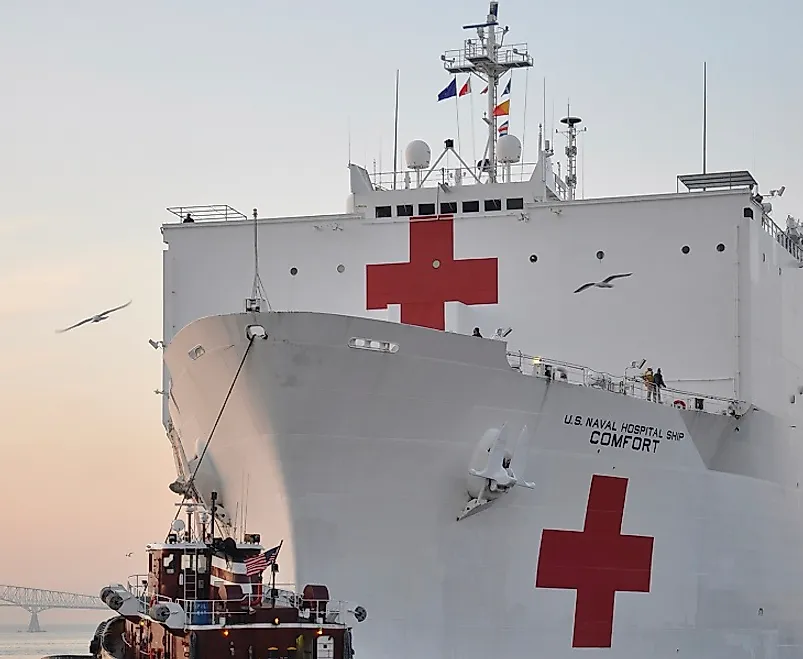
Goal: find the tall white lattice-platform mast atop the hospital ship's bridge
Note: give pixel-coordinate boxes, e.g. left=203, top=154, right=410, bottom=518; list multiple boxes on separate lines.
left=441, top=0, right=533, bottom=183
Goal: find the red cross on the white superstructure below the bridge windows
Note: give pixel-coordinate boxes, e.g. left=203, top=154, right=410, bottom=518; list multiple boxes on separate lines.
left=365, top=215, right=498, bottom=330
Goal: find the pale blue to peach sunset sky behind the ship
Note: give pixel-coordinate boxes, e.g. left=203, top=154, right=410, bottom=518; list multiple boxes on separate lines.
left=0, top=0, right=803, bottom=621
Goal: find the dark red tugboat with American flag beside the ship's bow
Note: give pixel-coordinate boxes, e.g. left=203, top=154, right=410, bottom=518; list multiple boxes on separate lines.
left=89, top=493, right=366, bottom=659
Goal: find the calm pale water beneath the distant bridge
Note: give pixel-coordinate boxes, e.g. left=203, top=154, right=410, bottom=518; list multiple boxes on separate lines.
left=0, top=618, right=97, bottom=659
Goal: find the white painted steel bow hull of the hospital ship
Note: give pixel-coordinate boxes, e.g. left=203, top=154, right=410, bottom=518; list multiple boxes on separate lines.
left=165, top=313, right=803, bottom=659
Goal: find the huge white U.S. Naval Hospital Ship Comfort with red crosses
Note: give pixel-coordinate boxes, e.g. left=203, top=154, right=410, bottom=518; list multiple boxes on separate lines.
left=152, top=2, right=803, bottom=659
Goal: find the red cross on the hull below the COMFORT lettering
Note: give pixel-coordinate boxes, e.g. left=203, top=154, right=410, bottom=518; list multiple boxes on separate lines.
left=535, top=475, right=655, bottom=648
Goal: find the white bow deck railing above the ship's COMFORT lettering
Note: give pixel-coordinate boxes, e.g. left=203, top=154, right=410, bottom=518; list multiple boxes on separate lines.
left=507, top=352, right=747, bottom=416
